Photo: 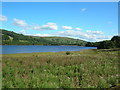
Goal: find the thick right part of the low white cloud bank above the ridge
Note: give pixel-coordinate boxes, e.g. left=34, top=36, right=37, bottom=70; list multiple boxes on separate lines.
left=54, top=30, right=111, bottom=42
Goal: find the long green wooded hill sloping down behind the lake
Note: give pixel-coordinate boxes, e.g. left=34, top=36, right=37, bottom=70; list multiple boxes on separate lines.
left=0, top=29, right=87, bottom=46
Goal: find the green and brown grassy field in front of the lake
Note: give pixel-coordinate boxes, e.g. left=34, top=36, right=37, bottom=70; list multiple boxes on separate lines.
left=2, top=50, right=120, bottom=88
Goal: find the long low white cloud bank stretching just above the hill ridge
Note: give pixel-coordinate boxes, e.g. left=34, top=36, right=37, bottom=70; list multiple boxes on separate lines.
left=20, top=30, right=112, bottom=42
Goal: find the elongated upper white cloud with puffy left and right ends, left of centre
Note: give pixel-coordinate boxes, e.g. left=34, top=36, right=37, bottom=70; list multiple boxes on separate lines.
left=13, top=18, right=58, bottom=30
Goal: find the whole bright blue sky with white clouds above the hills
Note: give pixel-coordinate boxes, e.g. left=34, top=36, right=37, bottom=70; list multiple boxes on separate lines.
left=0, top=2, right=118, bottom=42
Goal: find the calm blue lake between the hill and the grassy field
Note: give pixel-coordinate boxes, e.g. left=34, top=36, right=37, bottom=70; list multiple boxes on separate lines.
left=0, top=45, right=96, bottom=54
